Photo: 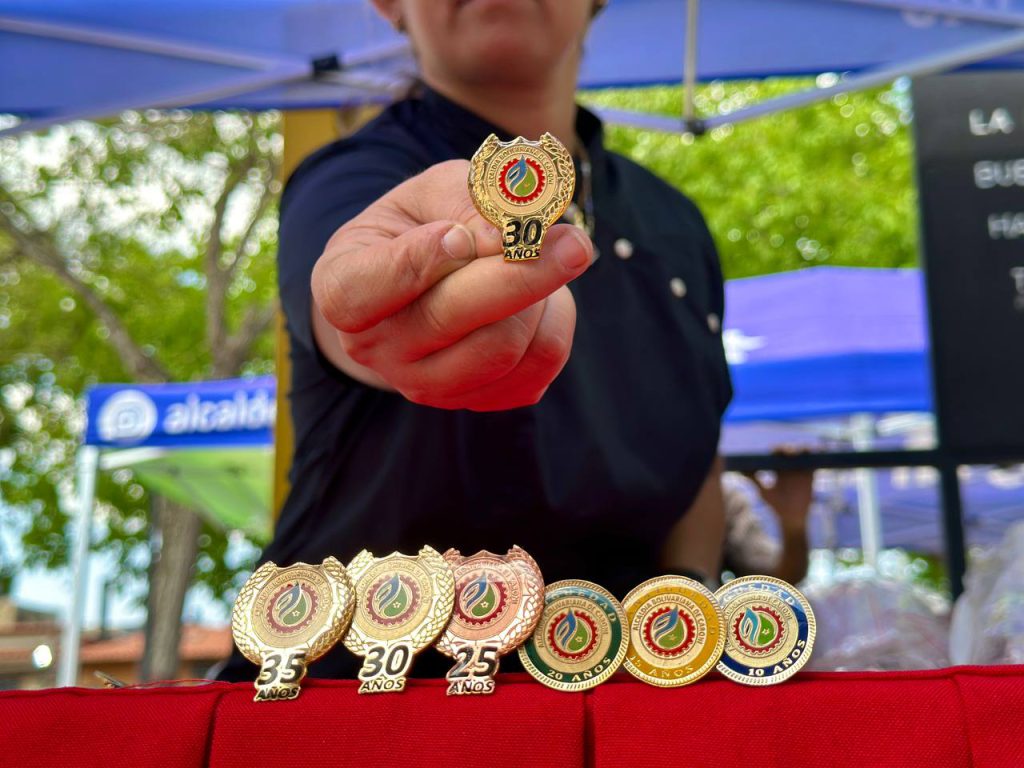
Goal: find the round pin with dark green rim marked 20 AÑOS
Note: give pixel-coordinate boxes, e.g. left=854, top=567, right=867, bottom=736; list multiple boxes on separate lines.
left=519, top=580, right=629, bottom=691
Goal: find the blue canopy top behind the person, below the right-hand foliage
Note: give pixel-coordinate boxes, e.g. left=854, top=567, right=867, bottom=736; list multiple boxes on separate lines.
left=723, top=266, right=932, bottom=422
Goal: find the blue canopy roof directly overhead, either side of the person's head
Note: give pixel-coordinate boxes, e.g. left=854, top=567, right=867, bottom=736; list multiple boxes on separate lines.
left=0, top=0, right=1024, bottom=130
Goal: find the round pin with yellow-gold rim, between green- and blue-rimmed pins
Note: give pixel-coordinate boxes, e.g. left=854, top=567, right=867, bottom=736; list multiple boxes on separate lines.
left=623, top=575, right=725, bottom=688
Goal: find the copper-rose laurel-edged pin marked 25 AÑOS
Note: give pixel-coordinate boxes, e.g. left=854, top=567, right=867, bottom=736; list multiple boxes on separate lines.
left=437, top=547, right=544, bottom=695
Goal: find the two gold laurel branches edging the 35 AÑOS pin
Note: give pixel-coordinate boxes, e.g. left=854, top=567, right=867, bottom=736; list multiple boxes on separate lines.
left=231, top=557, right=355, bottom=665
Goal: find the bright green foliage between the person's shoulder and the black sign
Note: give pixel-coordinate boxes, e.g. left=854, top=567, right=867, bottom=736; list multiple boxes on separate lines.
left=584, top=80, right=918, bottom=278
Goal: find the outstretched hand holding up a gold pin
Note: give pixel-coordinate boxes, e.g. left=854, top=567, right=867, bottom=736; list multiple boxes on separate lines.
left=312, top=160, right=594, bottom=411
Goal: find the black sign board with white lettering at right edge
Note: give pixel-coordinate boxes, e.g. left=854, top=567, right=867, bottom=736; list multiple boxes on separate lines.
left=913, top=72, right=1024, bottom=459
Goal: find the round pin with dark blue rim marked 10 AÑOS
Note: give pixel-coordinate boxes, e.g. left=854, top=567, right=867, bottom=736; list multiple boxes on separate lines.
left=715, top=575, right=815, bottom=685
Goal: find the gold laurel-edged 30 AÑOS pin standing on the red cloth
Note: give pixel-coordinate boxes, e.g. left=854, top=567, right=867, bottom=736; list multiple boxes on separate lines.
left=345, top=547, right=455, bottom=693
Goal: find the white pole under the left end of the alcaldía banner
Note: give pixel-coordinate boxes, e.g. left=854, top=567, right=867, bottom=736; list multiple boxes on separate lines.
left=57, top=445, right=99, bottom=686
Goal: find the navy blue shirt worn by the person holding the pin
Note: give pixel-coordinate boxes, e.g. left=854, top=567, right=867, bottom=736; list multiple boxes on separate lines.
left=225, top=90, right=731, bottom=677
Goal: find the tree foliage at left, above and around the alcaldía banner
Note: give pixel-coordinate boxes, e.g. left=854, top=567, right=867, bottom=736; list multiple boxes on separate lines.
left=0, top=111, right=282, bottom=600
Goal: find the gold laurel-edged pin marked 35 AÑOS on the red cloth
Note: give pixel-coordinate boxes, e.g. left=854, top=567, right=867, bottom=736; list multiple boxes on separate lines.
left=231, top=557, right=353, bottom=701
